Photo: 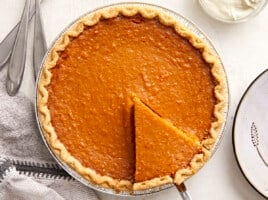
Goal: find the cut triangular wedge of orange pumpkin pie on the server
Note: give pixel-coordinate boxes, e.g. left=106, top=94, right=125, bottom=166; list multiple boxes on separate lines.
left=133, top=96, right=201, bottom=190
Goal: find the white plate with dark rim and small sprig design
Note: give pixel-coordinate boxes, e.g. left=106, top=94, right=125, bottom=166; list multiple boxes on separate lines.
left=233, top=69, right=268, bottom=198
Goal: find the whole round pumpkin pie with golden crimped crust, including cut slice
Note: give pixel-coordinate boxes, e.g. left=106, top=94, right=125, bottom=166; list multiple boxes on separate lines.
left=37, top=5, right=227, bottom=191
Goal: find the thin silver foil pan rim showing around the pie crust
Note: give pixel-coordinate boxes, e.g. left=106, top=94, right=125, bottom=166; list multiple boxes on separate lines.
left=35, top=3, right=229, bottom=196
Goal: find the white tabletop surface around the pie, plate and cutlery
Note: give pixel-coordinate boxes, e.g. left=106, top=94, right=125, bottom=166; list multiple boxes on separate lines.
left=0, top=0, right=268, bottom=200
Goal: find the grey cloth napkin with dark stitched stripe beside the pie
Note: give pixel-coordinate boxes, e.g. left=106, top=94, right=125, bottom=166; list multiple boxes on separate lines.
left=0, top=76, right=98, bottom=200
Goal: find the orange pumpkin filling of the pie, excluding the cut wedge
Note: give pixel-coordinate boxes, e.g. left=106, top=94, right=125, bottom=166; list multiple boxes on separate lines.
left=48, top=16, right=216, bottom=181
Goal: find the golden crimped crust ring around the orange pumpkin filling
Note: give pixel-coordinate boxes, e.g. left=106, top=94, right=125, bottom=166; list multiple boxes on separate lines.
left=37, top=5, right=227, bottom=191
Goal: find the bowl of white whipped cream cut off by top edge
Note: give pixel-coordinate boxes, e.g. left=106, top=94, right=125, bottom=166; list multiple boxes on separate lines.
left=199, top=0, right=265, bottom=21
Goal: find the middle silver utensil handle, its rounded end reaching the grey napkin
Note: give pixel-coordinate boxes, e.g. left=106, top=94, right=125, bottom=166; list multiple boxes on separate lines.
left=6, top=0, right=31, bottom=96
